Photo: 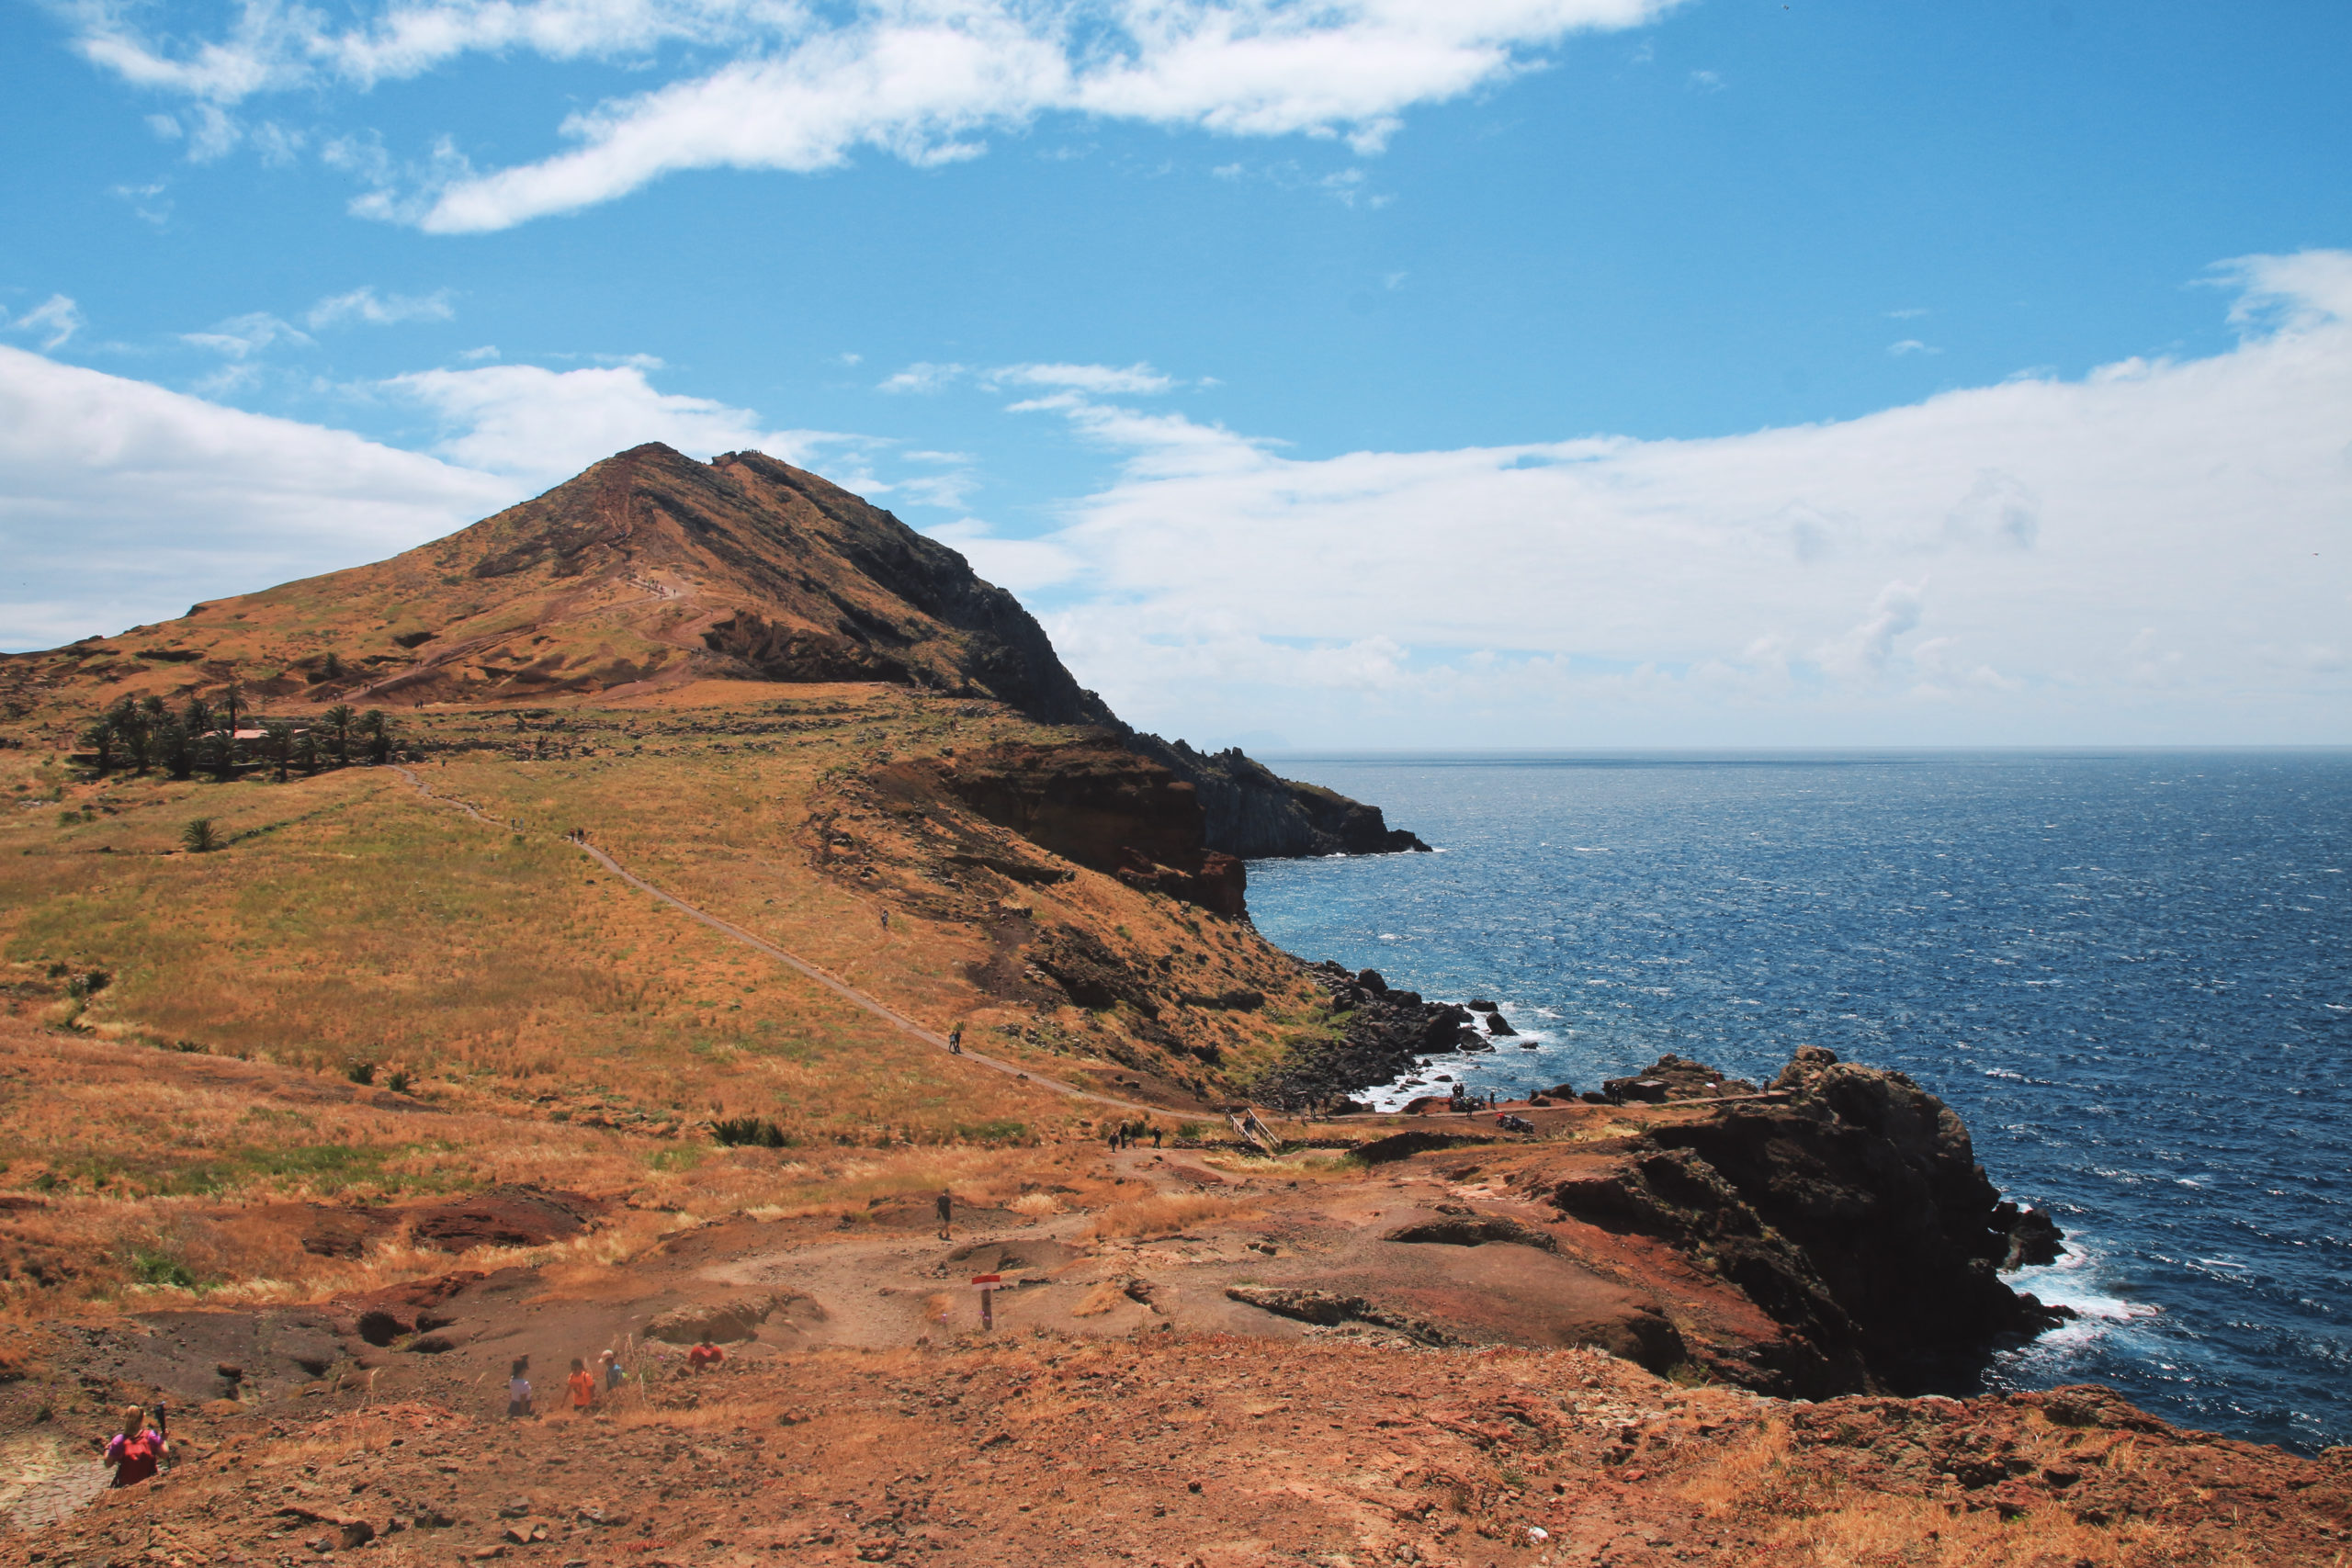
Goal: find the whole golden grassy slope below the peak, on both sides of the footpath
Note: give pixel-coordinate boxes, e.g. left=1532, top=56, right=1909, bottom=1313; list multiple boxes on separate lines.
left=0, top=684, right=1319, bottom=1309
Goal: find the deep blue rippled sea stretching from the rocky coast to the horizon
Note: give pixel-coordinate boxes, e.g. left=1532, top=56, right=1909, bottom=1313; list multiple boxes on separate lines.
left=1249, top=752, right=2352, bottom=1450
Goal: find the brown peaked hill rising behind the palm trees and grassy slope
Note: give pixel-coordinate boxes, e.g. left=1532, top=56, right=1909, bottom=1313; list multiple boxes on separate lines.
left=0, top=442, right=1110, bottom=724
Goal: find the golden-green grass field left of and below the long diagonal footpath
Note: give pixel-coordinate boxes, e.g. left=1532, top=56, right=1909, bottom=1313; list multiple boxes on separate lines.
left=0, top=719, right=1068, bottom=1143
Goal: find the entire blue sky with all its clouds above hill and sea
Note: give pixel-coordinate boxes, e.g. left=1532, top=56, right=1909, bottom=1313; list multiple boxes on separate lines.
left=0, top=0, right=2352, bottom=745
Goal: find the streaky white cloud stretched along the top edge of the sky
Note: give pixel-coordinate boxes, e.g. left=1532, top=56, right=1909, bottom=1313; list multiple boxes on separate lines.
left=55, top=0, right=1677, bottom=232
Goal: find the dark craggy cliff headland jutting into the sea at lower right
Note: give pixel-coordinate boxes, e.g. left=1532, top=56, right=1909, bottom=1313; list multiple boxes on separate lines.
left=1512, top=1046, right=2070, bottom=1396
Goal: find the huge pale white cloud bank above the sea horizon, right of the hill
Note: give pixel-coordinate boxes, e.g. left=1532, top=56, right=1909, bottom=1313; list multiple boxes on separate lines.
left=1033, top=252, right=2352, bottom=743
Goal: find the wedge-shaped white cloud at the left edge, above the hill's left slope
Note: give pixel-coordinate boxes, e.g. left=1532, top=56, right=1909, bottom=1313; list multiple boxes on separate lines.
left=0, top=348, right=525, bottom=649
